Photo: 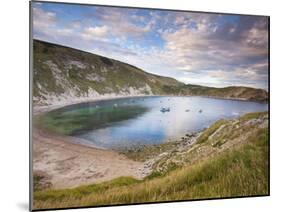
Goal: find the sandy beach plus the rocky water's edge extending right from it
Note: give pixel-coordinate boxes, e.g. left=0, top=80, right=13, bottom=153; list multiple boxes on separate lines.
left=32, top=123, right=200, bottom=190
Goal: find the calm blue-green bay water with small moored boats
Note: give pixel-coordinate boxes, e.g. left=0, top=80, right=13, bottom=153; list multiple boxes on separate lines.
left=43, top=97, right=268, bottom=149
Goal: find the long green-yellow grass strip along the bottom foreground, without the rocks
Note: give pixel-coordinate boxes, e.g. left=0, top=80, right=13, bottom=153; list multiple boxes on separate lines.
left=34, top=128, right=268, bottom=209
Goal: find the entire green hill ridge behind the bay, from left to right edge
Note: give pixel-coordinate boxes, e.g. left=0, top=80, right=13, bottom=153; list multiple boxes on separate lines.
left=33, top=40, right=268, bottom=106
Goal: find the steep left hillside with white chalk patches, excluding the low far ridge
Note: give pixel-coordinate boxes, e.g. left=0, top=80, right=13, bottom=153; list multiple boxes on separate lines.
left=33, top=40, right=183, bottom=104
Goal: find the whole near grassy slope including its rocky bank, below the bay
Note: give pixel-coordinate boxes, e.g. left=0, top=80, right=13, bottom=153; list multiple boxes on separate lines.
left=34, top=112, right=269, bottom=209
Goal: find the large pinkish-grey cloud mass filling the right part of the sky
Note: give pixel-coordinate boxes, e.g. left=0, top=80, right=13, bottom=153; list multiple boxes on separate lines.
left=155, top=15, right=268, bottom=86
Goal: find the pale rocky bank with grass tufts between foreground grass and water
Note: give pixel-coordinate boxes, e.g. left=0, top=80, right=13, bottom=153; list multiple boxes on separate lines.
left=148, top=112, right=268, bottom=174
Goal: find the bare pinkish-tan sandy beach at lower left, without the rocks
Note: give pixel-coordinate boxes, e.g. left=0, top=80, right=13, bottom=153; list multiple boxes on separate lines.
left=33, top=129, right=149, bottom=188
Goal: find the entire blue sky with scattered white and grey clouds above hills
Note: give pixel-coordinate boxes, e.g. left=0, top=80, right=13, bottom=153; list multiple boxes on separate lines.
left=32, top=2, right=269, bottom=90
